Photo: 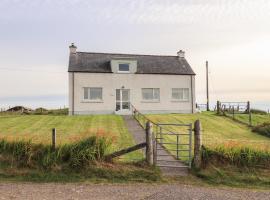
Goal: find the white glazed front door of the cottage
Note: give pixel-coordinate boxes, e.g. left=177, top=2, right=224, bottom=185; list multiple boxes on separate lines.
left=115, top=89, right=130, bottom=114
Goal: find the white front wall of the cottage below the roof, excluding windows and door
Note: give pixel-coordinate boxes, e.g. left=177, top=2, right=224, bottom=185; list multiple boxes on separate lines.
left=69, top=72, right=195, bottom=114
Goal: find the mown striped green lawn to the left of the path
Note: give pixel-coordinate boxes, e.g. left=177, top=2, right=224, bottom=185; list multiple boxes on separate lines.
left=0, top=115, right=142, bottom=160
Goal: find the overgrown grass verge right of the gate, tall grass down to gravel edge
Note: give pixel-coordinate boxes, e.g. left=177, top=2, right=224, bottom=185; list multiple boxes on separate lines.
left=193, top=146, right=270, bottom=189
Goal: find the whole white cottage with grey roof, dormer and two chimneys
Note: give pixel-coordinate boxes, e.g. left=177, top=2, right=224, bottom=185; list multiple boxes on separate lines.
left=68, top=44, right=195, bottom=115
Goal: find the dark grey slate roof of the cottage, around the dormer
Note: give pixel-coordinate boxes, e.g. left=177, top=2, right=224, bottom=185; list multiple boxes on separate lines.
left=68, top=52, right=195, bottom=75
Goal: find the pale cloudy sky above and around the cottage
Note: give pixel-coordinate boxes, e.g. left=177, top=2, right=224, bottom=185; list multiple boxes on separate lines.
left=0, top=0, right=270, bottom=107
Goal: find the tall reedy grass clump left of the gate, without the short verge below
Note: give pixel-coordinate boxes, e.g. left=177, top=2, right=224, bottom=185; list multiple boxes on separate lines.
left=0, top=136, right=111, bottom=169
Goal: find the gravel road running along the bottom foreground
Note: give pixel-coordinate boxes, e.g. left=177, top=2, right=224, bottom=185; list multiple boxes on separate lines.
left=0, top=183, right=270, bottom=200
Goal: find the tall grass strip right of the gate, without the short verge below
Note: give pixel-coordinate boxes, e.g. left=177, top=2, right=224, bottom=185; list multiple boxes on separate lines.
left=202, top=146, right=270, bottom=169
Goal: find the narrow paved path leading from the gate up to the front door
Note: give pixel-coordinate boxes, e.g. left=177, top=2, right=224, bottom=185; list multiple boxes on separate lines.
left=123, top=115, right=188, bottom=176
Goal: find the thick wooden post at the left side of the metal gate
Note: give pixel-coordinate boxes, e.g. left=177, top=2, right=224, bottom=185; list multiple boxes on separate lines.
left=145, top=121, right=154, bottom=165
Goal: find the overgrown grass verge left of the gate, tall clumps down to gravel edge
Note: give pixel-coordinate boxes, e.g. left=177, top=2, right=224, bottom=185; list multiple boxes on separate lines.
left=0, top=136, right=161, bottom=183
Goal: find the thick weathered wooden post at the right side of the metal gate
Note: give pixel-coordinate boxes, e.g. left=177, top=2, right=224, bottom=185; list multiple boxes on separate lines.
left=194, top=120, right=202, bottom=168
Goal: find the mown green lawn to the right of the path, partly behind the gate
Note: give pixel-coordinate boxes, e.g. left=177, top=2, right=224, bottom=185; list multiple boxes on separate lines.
left=147, top=112, right=270, bottom=149
